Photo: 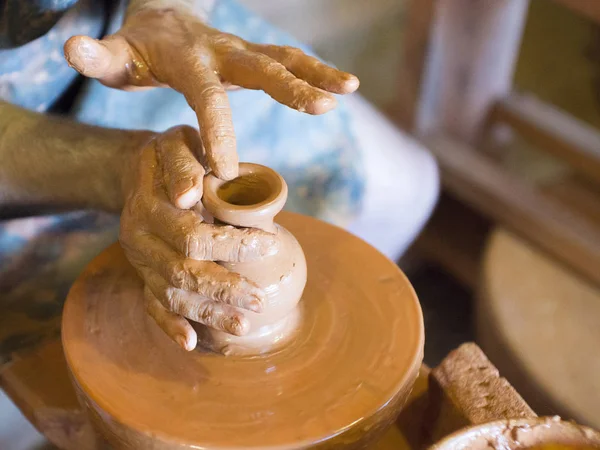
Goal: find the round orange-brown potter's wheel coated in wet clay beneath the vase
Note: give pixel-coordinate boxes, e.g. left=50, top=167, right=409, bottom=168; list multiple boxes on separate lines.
left=63, top=213, right=423, bottom=449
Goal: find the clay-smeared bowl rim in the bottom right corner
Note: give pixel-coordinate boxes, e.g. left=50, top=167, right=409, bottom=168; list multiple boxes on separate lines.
left=430, top=417, right=600, bottom=450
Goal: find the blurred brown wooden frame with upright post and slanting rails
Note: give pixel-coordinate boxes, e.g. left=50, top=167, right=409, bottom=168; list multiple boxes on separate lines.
left=394, top=0, right=600, bottom=287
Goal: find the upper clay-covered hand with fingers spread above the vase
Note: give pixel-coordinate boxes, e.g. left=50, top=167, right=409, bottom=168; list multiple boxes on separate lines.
left=65, top=9, right=359, bottom=179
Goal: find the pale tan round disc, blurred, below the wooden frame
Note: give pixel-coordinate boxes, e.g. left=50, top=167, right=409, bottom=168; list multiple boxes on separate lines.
left=476, top=228, right=600, bottom=428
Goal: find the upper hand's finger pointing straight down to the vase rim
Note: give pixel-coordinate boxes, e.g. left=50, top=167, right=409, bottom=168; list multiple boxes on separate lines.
left=177, top=66, right=239, bottom=180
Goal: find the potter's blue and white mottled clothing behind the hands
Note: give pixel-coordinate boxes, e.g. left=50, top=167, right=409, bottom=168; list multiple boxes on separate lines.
left=0, top=0, right=363, bottom=361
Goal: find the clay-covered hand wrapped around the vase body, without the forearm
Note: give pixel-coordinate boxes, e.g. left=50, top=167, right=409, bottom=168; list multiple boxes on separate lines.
left=124, top=127, right=278, bottom=350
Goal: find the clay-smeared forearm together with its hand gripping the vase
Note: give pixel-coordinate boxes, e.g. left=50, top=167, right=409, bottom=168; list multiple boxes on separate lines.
left=0, top=102, right=279, bottom=350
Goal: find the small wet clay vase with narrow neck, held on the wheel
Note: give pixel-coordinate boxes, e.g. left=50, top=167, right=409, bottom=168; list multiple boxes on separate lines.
left=195, top=163, right=306, bottom=355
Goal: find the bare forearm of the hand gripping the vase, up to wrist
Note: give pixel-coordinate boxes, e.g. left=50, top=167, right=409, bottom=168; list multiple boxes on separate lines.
left=0, top=102, right=150, bottom=212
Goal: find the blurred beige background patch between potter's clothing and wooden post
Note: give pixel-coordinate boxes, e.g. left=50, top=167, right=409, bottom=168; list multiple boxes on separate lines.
left=241, top=0, right=406, bottom=106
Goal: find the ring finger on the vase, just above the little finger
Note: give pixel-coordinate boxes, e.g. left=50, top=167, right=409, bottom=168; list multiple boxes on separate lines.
left=144, top=266, right=250, bottom=336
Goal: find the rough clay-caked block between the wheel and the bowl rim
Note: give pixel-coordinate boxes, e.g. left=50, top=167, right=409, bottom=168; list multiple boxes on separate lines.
left=424, top=343, right=536, bottom=443
